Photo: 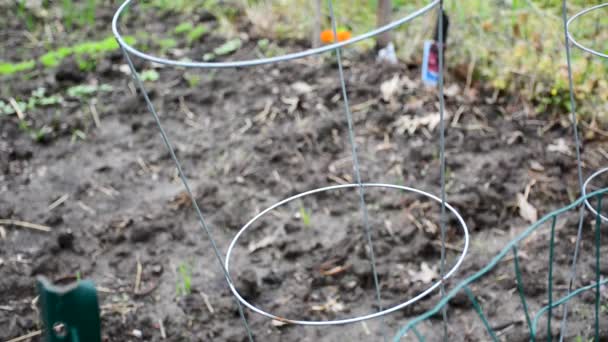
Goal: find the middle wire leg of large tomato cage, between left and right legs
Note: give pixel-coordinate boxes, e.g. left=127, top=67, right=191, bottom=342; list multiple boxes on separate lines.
left=327, top=0, right=387, bottom=342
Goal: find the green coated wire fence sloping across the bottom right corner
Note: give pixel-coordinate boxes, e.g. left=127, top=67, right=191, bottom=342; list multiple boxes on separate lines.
left=394, top=188, right=608, bottom=342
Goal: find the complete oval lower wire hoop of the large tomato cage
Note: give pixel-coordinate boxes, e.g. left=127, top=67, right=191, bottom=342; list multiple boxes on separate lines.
left=225, top=183, right=469, bottom=326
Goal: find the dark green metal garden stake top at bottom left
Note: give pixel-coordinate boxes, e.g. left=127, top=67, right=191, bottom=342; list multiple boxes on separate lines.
left=38, top=277, right=101, bottom=342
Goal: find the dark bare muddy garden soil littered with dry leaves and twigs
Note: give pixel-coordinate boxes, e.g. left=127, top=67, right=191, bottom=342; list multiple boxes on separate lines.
left=0, top=1, right=608, bottom=341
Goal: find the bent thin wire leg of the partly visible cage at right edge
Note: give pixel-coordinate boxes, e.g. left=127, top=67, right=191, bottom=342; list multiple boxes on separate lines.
left=559, top=0, right=585, bottom=342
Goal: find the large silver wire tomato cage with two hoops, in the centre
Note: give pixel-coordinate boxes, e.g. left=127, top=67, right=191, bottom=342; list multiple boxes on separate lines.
left=112, top=0, right=469, bottom=341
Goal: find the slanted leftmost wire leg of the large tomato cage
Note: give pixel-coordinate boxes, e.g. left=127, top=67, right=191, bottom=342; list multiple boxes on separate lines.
left=118, top=45, right=253, bottom=342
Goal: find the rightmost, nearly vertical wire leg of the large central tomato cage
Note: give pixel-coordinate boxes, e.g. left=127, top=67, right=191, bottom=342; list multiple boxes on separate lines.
left=437, top=0, right=448, bottom=341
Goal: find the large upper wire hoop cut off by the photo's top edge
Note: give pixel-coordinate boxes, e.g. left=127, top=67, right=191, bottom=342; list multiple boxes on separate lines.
left=112, top=0, right=440, bottom=69
